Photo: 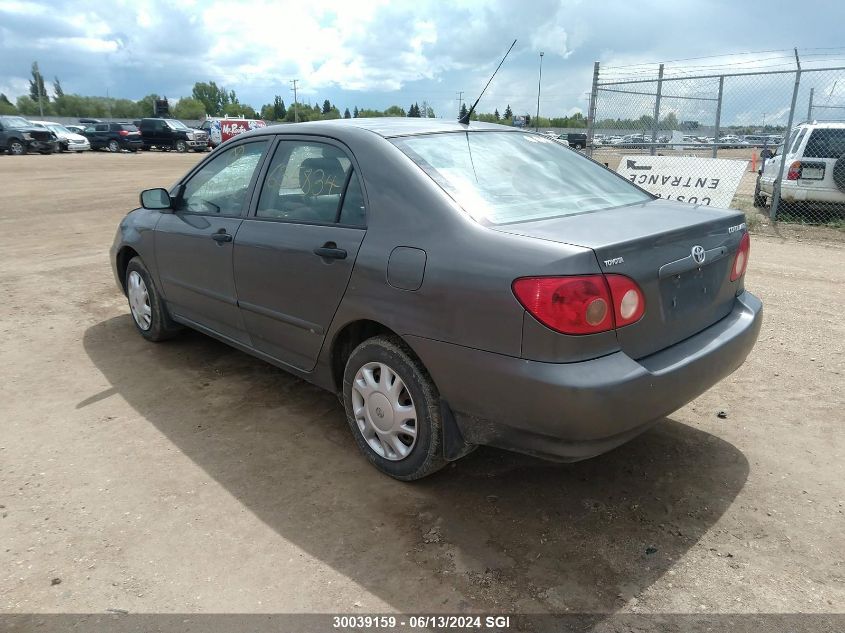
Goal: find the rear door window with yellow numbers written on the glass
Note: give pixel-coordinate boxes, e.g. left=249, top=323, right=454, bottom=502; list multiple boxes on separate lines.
left=256, top=141, right=363, bottom=226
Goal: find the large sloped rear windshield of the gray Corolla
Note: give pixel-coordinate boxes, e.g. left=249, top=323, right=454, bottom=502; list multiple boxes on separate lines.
left=393, top=132, right=653, bottom=224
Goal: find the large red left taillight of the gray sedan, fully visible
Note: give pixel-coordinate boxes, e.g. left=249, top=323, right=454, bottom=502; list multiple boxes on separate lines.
left=513, top=275, right=645, bottom=334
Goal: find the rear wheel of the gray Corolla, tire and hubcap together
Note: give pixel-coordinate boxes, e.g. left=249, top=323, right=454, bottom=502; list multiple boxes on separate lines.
left=343, top=336, right=446, bottom=481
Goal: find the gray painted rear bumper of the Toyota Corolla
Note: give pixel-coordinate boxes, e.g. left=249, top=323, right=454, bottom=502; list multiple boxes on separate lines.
left=407, top=292, right=763, bottom=461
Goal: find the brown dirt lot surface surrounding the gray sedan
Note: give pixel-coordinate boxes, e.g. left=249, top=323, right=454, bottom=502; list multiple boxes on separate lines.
left=0, top=152, right=845, bottom=613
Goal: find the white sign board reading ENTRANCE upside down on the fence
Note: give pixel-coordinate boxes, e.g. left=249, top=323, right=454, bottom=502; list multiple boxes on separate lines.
left=616, top=156, right=748, bottom=207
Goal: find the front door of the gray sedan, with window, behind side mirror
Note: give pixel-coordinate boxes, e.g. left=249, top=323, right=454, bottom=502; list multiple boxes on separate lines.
left=155, top=138, right=270, bottom=345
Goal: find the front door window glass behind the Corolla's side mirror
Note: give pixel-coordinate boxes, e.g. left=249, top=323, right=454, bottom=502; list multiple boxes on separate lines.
left=179, top=141, right=269, bottom=216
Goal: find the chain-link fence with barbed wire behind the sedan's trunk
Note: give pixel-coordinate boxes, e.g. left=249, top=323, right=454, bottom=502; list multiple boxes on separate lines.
left=587, top=51, right=845, bottom=226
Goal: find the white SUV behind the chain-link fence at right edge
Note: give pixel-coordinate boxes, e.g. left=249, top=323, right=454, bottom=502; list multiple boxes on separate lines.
left=754, top=121, right=845, bottom=207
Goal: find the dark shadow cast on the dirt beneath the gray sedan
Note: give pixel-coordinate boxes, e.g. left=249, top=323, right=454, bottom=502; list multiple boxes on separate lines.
left=82, top=315, right=749, bottom=613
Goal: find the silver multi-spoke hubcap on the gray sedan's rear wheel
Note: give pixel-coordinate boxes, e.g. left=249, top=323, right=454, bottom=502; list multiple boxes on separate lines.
left=352, top=362, right=417, bottom=462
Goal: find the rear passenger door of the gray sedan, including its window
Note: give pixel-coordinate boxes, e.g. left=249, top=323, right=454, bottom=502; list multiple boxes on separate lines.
left=234, top=138, right=366, bottom=371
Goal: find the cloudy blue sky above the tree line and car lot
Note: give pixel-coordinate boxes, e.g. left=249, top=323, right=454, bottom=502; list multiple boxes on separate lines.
left=0, top=0, right=845, bottom=123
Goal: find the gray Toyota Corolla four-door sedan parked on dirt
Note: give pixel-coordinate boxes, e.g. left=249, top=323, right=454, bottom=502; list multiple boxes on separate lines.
left=112, top=119, right=762, bottom=480
